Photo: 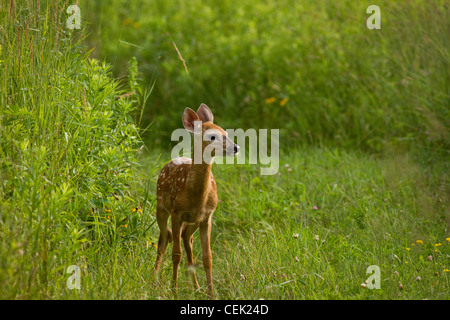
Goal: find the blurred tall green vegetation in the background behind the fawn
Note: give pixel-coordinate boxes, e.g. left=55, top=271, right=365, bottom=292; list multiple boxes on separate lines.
left=83, top=0, right=450, bottom=160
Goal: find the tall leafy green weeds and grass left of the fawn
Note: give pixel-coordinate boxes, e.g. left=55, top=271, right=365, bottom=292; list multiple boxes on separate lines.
left=0, top=1, right=152, bottom=299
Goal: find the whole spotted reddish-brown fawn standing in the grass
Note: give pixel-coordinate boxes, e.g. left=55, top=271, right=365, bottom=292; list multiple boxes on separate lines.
left=155, top=103, right=239, bottom=297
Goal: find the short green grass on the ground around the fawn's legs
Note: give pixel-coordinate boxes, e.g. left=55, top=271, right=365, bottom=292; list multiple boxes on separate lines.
left=18, top=148, right=450, bottom=300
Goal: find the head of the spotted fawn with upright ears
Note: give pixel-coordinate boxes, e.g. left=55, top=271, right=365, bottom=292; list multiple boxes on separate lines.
left=183, top=103, right=240, bottom=159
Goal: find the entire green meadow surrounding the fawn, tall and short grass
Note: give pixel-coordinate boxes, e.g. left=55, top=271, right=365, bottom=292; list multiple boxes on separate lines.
left=0, top=0, right=450, bottom=300
